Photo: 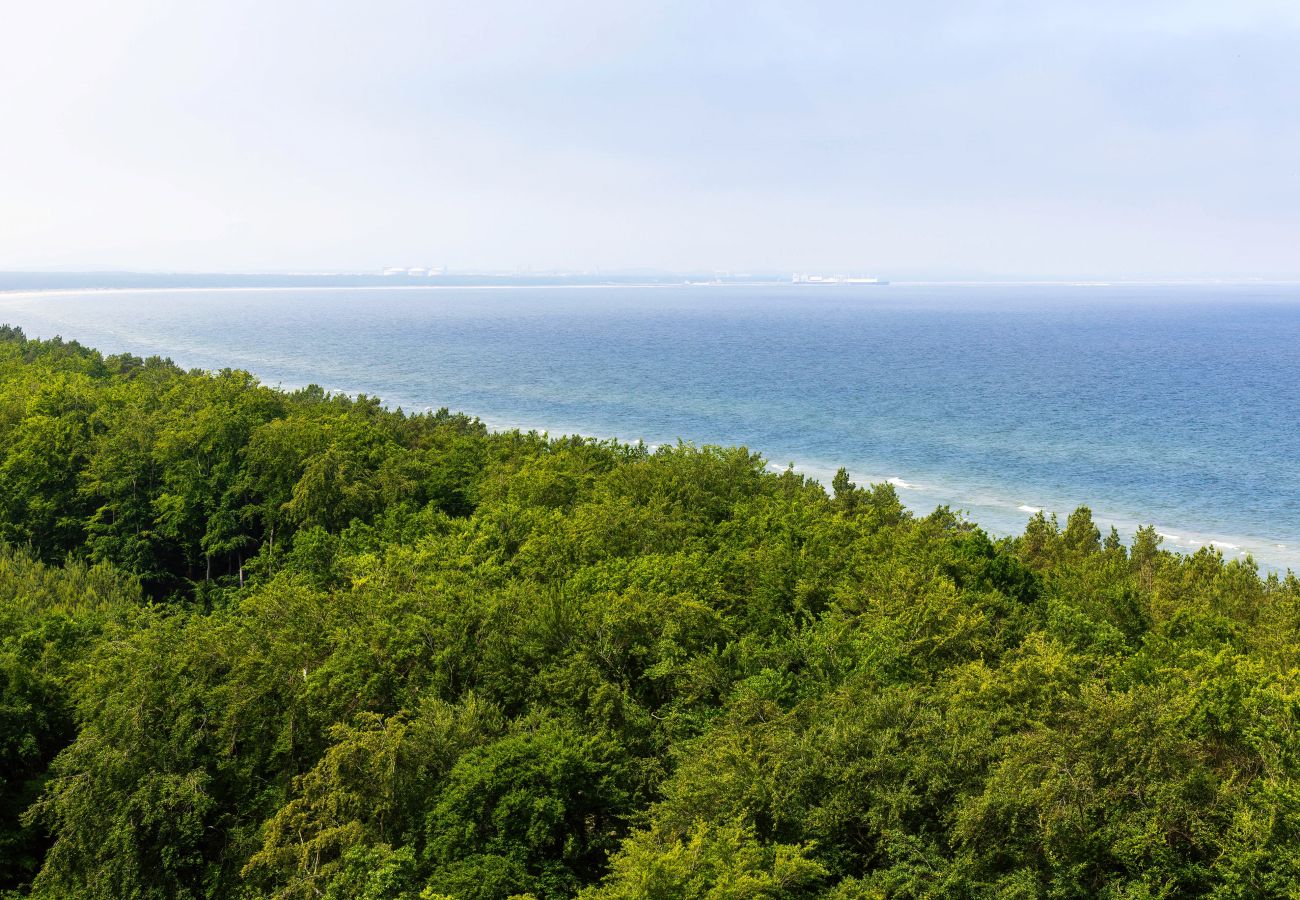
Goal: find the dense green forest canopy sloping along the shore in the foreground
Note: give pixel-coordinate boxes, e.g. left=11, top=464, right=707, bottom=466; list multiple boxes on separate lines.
left=0, top=328, right=1300, bottom=900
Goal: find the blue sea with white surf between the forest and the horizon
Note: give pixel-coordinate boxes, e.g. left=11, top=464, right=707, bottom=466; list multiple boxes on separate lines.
left=0, top=285, right=1300, bottom=568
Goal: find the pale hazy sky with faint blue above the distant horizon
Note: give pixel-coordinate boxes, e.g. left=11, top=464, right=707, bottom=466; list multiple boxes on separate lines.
left=0, top=0, right=1300, bottom=277
